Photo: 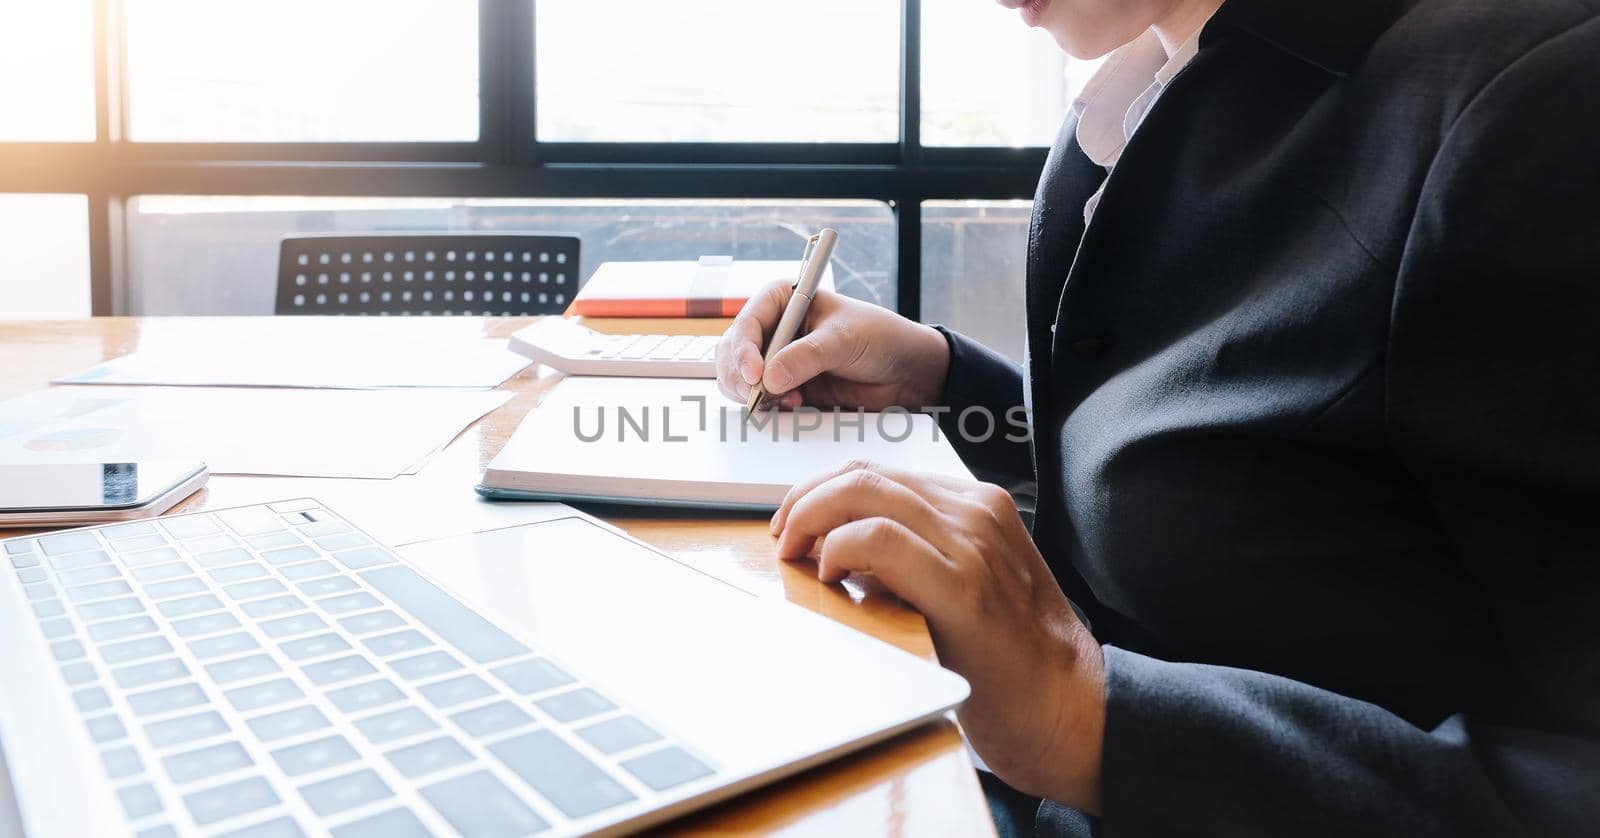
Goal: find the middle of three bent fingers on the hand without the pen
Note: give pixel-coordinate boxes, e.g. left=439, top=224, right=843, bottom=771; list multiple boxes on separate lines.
left=778, top=469, right=950, bottom=558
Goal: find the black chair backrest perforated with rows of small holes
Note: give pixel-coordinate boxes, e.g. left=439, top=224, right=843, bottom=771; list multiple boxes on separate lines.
left=275, top=233, right=579, bottom=315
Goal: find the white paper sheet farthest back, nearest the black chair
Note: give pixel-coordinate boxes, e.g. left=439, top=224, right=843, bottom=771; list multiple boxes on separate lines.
left=54, top=317, right=533, bottom=389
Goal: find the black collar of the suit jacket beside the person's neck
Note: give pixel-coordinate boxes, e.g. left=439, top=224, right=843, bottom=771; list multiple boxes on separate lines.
left=1202, top=0, right=1414, bottom=75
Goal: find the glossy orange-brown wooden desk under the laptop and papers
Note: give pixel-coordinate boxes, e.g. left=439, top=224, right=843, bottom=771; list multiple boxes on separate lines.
left=0, top=318, right=994, bottom=836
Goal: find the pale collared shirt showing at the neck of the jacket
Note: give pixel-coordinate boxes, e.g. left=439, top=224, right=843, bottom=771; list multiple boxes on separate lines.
left=1072, top=29, right=1200, bottom=224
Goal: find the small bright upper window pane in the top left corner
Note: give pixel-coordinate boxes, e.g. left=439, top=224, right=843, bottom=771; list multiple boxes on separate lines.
left=0, top=0, right=94, bottom=142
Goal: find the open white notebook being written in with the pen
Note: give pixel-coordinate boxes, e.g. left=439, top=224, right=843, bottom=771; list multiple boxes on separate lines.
left=478, top=377, right=971, bottom=510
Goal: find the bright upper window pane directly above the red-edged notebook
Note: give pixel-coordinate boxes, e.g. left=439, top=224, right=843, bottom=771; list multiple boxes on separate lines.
left=534, top=0, right=896, bottom=142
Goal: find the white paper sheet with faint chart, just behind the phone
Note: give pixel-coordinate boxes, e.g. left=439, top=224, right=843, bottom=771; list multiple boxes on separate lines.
left=0, top=387, right=512, bottom=476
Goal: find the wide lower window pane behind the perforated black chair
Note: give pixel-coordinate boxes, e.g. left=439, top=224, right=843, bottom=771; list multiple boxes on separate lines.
left=128, top=195, right=894, bottom=315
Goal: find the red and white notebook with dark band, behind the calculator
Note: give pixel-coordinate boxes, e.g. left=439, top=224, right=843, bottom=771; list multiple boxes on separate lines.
left=571, top=256, right=834, bottom=317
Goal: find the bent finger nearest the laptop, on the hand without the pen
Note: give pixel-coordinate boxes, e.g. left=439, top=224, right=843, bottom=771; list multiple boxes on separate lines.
left=816, top=518, right=960, bottom=624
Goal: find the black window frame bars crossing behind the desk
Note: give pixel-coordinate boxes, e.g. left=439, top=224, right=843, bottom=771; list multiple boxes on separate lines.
left=0, top=0, right=1046, bottom=318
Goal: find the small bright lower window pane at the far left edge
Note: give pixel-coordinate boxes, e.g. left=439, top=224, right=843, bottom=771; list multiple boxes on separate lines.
left=0, top=195, right=90, bottom=320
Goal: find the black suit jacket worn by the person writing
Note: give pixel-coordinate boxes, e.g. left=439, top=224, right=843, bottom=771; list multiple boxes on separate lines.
left=947, top=0, right=1600, bottom=836
